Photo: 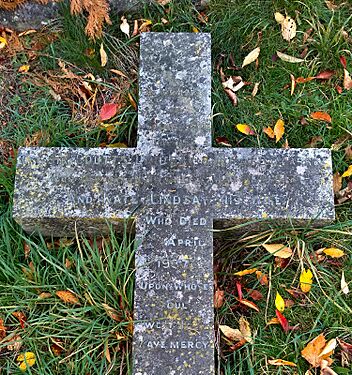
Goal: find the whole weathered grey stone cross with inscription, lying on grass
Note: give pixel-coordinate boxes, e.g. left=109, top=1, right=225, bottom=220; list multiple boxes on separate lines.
left=13, top=33, right=334, bottom=375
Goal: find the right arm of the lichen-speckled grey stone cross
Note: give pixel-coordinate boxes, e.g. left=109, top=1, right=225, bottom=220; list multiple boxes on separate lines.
left=212, top=148, right=335, bottom=226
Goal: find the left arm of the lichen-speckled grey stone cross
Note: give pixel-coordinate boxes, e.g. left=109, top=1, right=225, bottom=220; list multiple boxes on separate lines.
left=13, top=147, right=139, bottom=236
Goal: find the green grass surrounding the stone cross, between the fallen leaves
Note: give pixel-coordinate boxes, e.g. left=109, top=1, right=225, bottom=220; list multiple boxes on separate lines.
left=0, top=0, right=352, bottom=375
